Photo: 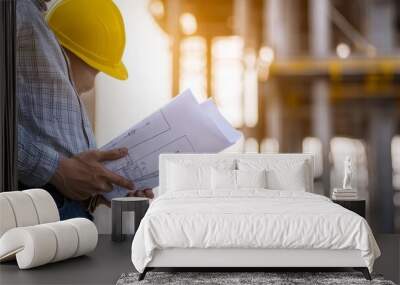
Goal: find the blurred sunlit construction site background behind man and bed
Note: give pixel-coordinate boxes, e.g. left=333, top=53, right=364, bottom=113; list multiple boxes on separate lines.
left=82, top=0, right=400, bottom=233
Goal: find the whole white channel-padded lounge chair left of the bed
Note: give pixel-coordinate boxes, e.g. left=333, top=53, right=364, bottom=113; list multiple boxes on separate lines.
left=0, top=189, right=98, bottom=269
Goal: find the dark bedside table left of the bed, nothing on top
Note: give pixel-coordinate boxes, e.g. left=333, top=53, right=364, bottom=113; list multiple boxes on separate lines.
left=111, top=197, right=150, bottom=241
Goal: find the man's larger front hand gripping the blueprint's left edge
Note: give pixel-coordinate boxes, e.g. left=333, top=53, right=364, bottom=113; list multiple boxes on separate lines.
left=50, top=148, right=134, bottom=200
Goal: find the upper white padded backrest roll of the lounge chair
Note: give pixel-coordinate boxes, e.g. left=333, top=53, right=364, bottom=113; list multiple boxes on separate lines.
left=0, top=189, right=60, bottom=237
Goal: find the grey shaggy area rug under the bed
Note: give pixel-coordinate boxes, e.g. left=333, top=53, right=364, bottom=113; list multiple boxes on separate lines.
left=117, top=272, right=395, bottom=285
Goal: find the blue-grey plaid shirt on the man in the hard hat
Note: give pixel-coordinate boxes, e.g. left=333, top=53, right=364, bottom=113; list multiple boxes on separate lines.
left=16, top=0, right=96, bottom=187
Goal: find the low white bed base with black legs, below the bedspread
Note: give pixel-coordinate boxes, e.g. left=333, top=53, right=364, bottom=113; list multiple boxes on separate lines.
left=139, top=248, right=371, bottom=280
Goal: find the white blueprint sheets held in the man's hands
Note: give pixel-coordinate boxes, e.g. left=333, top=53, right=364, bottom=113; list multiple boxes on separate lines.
left=101, top=90, right=241, bottom=200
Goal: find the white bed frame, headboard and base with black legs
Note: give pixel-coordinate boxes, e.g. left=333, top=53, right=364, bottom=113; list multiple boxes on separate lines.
left=139, top=153, right=371, bottom=280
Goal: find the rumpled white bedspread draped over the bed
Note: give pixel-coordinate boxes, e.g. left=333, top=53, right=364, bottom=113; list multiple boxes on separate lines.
left=132, top=189, right=380, bottom=272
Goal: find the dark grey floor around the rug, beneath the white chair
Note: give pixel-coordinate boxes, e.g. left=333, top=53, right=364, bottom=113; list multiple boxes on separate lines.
left=0, top=235, right=400, bottom=285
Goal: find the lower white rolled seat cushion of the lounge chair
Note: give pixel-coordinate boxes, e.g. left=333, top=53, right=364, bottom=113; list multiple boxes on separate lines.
left=0, top=218, right=98, bottom=269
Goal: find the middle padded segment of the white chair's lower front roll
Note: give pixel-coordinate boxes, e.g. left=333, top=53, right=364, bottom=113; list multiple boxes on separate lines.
left=42, top=221, right=79, bottom=262
